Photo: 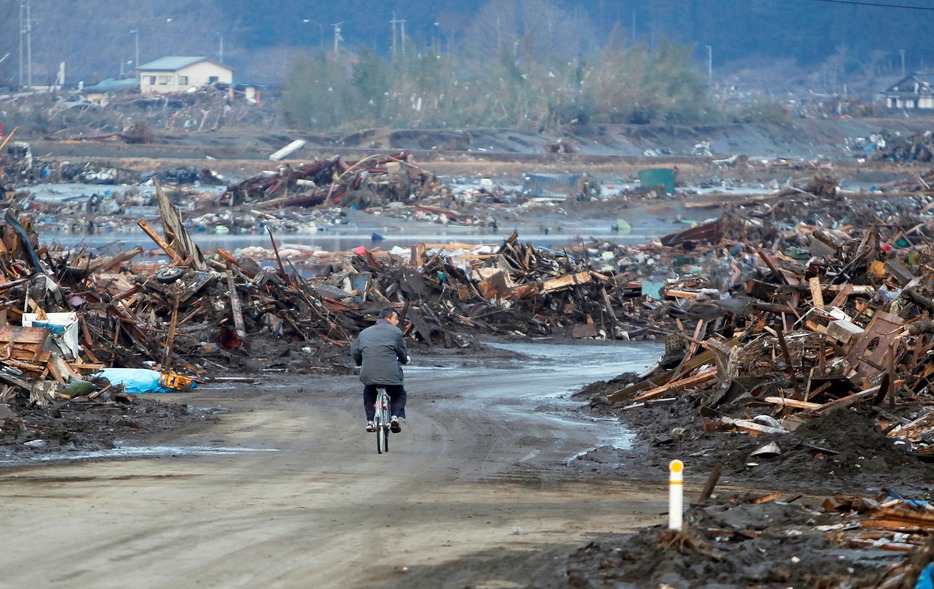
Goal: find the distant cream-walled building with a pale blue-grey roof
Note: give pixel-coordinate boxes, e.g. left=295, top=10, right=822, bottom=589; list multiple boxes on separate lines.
left=138, top=56, right=233, bottom=96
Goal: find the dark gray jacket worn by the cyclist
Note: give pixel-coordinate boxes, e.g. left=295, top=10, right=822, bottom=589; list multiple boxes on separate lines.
left=350, top=319, right=409, bottom=384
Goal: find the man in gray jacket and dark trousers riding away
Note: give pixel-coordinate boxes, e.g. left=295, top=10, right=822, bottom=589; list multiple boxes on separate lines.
left=350, top=307, right=409, bottom=433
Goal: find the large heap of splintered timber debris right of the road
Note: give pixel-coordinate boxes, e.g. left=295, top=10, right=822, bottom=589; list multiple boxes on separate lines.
left=588, top=177, right=934, bottom=457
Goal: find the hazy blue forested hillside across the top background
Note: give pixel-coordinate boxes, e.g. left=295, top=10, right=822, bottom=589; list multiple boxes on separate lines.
left=0, top=0, right=934, bottom=84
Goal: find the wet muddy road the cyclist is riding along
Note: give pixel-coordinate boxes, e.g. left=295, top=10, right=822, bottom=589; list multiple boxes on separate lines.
left=0, top=344, right=667, bottom=588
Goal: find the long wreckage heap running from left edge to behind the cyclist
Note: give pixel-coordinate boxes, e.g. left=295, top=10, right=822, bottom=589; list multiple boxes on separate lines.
left=0, top=183, right=668, bottom=402
